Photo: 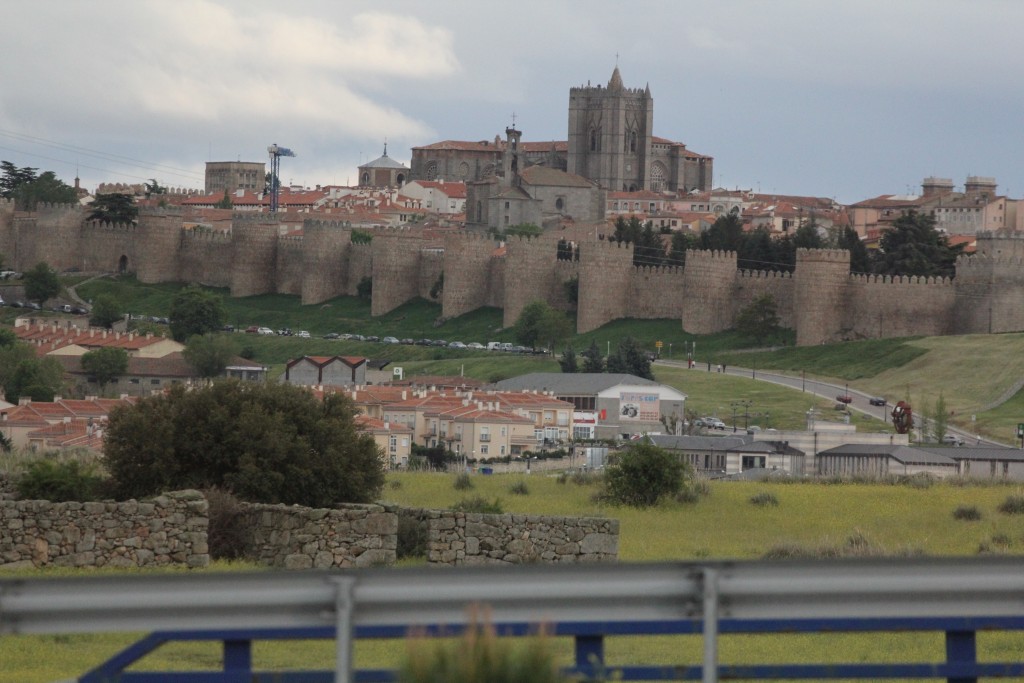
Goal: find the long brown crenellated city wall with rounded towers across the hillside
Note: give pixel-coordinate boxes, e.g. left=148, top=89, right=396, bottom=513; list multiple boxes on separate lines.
left=8, top=201, right=1024, bottom=345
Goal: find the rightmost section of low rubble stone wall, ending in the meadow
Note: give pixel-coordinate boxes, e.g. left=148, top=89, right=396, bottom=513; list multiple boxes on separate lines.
left=398, top=508, right=618, bottom=566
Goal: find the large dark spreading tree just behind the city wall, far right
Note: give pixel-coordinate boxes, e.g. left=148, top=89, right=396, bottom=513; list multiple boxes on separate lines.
left=874, top=211, right=964, bottom=278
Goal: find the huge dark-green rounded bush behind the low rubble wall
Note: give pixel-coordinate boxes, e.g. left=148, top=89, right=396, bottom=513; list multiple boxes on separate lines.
left=103, top=380, right=384, bottom=508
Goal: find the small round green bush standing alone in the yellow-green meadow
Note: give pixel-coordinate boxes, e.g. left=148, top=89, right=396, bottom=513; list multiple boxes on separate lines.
left=604, top=439, right=692, bottom=508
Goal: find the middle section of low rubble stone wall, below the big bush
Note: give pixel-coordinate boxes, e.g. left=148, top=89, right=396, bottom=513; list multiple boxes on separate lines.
left=237, top=504, right=398, bottom=569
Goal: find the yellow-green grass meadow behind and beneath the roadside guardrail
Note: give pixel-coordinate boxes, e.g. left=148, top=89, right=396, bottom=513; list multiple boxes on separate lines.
left=6, top=473, right=1024, bottom=683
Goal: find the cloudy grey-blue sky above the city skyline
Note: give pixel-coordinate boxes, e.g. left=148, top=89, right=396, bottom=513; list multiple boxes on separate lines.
left=0, top=0, right=1024, bottom=203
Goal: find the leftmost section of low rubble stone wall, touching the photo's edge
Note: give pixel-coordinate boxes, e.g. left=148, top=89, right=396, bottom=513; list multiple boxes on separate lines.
left=0, top=490, right=210, bottom=569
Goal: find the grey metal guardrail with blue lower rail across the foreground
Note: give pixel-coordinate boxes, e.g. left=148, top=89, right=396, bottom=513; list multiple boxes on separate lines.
left=0, top=557, right=1024, bottom=683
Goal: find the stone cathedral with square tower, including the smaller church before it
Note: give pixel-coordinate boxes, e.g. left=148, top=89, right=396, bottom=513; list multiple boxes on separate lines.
left=410, top=67, right=714, bottom=229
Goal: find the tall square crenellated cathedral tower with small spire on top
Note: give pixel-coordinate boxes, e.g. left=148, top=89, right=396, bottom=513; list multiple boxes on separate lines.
left=566, top=67, right=654, bottom=190
